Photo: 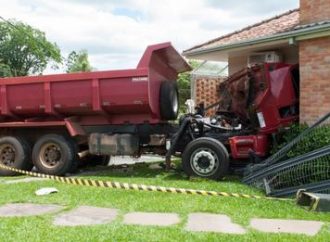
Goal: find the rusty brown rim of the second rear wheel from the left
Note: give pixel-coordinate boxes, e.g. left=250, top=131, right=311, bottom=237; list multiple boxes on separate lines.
left=39, top=143, right=63, bottom=168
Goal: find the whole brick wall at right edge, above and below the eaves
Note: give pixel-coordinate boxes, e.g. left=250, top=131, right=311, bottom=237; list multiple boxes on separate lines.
left=299, top=0, right=330, bottom=124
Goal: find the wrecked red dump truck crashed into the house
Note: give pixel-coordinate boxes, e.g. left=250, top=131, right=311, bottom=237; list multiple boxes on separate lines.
left=0, top=43, right=298, bottom=179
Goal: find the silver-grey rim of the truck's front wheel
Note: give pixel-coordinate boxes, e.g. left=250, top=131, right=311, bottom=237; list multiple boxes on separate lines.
left=190, top=148, right=220, bottom=176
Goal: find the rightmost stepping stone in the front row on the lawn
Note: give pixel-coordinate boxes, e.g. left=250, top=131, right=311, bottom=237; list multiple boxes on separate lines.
left=250, top=218, right=323, bottom=235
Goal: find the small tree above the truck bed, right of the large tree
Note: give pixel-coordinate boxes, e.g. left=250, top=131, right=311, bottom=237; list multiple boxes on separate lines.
left=66, top=50, right=93, bottom=73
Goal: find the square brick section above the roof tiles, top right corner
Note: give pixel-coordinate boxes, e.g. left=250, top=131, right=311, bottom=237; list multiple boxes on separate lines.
left=300, top=0, right=330, bottom=24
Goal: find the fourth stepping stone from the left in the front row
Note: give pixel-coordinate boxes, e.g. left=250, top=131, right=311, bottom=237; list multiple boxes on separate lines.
left=185, top=213, right=246, bottom=234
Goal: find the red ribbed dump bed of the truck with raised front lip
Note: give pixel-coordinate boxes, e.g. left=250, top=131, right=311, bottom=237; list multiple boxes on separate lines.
left=0, top=43, right=189, bottom=125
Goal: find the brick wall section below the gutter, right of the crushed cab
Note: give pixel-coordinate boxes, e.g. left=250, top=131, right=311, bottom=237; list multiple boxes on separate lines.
left=299, top=37, right=330, bottom=124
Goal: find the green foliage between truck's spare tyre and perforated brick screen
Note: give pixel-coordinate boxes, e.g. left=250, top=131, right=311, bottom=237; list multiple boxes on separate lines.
left=177, top=60, right=199, bottom=113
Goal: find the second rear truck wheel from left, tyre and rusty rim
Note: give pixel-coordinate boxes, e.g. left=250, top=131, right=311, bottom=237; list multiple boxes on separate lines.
left=32, top=134, right=77, bottom=175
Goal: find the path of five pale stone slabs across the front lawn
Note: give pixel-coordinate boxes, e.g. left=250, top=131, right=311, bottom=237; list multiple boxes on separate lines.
left=0, top=203, right=323, bottom=236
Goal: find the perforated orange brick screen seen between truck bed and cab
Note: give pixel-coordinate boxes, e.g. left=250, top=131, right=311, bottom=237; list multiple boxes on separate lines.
left=195, top=77, right=223, bottom=116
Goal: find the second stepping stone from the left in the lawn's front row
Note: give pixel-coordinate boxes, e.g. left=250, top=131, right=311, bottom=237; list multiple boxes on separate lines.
left=53, top=206, right=118, bottom=226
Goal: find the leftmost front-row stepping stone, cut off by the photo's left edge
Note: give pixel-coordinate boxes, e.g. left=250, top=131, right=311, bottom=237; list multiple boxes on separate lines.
left=0, top=203, right=64, bottom=217
